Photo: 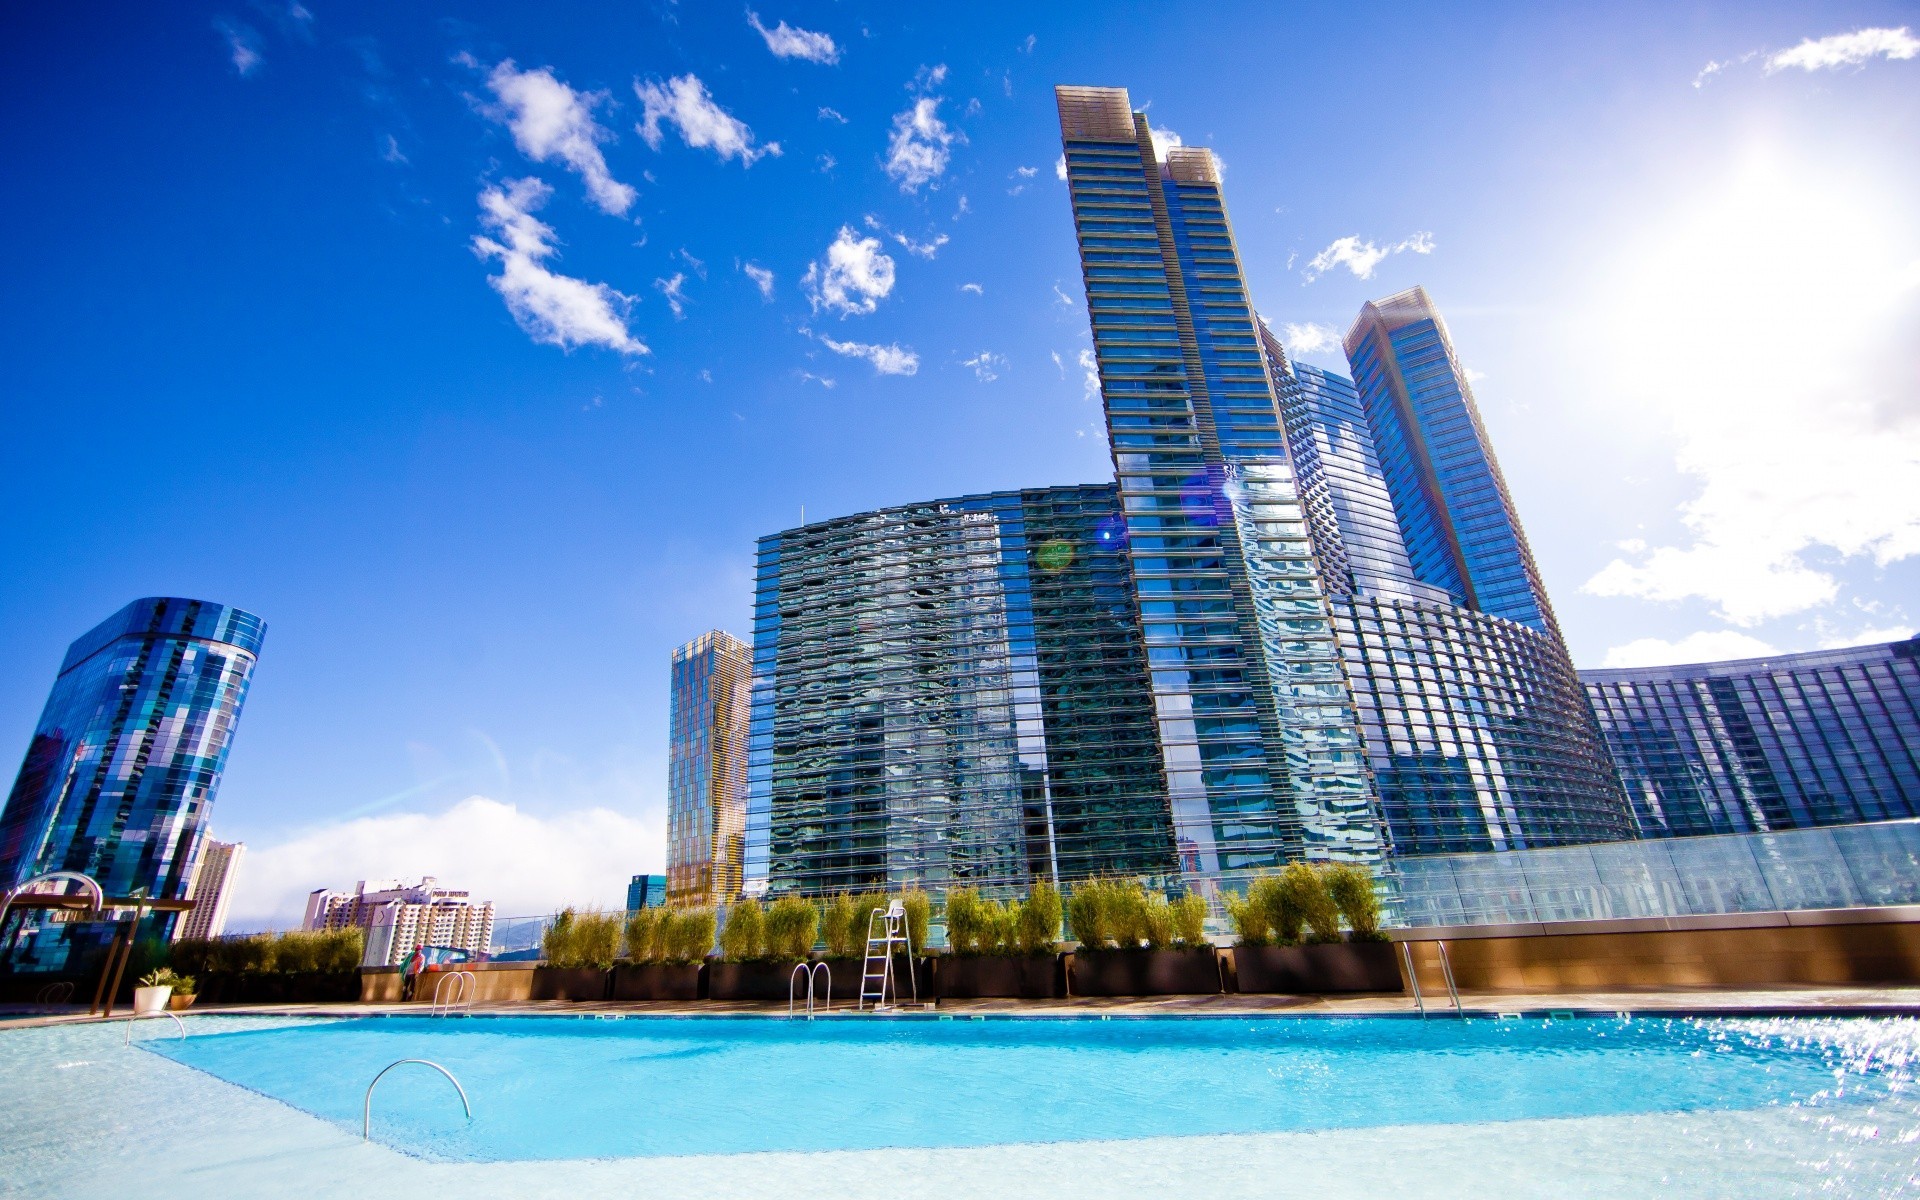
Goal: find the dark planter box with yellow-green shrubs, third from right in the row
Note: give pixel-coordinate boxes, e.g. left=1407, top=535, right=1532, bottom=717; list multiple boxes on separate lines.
left=939, top=879, right=1066, bottom=1000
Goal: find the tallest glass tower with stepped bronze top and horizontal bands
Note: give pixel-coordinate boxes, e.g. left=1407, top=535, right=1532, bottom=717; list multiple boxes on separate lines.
left=1056, top=86, right=1382, bottom=881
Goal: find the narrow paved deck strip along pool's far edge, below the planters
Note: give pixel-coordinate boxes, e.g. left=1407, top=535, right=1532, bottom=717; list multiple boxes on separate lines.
left=0, top=987, right=1920, bottom=1029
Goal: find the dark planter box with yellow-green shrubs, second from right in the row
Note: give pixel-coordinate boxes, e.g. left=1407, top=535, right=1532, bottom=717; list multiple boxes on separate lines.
left=1068, top=879, right=1221, bottom=996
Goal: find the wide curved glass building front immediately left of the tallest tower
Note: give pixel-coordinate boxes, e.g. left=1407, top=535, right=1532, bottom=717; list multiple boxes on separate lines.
left=747, top=484, right=1175, bottom=895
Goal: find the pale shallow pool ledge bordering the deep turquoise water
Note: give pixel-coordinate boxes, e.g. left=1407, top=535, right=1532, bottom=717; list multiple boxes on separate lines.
left=0, top=1016, right=1920, bottom=1200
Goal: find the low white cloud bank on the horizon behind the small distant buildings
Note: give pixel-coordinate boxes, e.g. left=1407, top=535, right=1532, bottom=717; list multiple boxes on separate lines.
left=232, top=795, right=666, bottom=929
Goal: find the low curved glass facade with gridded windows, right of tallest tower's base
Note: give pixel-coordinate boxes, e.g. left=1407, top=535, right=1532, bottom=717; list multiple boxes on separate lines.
left=1334, top=595, right=1634, bottom=854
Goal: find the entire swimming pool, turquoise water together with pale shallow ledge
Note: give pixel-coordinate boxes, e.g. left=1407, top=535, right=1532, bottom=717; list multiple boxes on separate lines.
left=0, top=1016, right=1920, bottom=1200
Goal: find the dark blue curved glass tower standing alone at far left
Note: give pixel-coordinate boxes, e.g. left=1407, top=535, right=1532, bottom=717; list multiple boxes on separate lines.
left=0, top=597, right=265, bottom=900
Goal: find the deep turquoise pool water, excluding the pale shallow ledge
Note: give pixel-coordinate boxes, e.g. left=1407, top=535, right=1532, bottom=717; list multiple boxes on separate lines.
left=153, top=1018, right=1920, bottom=1164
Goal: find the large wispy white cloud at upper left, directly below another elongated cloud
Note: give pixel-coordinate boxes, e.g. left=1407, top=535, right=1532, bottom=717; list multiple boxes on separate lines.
left=472, top=179, right=649, bottom=353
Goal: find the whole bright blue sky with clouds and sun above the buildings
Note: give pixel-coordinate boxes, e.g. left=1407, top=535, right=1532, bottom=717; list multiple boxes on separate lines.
left=0, top=0, right=1920, bottom=922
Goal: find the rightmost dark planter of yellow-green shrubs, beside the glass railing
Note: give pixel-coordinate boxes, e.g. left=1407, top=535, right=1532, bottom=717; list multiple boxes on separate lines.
left=1227, top=862, right=1402, bottom=995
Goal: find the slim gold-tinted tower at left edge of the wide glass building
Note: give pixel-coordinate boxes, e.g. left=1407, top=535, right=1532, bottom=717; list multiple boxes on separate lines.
left=666, top=630, right=753, bottom=904
